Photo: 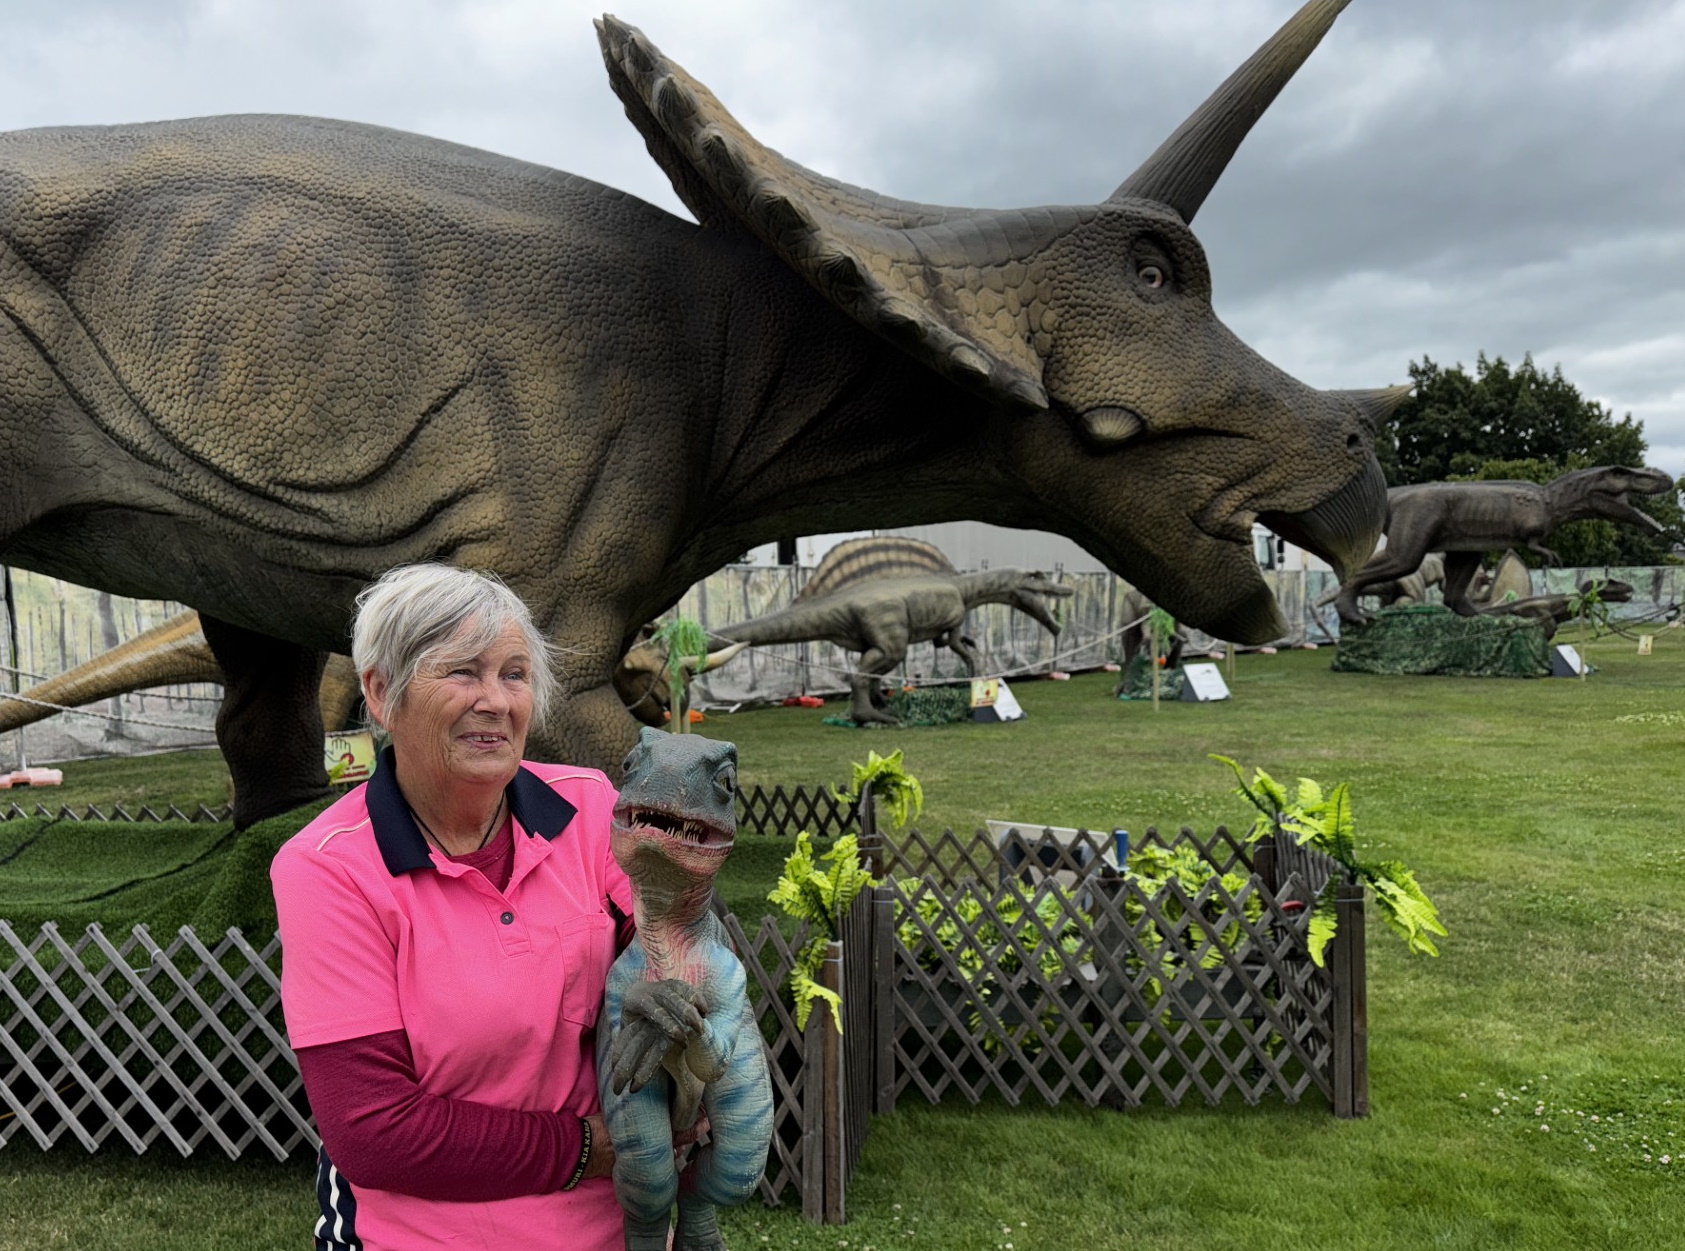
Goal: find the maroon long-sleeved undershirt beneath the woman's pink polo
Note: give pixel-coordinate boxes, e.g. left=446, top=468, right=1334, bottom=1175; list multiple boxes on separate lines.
left=289, top=830, right=632, bottom=1202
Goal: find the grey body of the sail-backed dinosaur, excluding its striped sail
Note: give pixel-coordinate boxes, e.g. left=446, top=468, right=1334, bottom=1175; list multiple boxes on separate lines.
left=718, top=570, right=1075, bottom=725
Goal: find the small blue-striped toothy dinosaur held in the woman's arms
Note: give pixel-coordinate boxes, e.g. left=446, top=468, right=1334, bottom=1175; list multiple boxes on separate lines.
left=596, top=728, right=772, bottom=1251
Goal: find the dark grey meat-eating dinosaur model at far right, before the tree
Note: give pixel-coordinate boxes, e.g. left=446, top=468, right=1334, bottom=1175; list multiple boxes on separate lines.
left=1335, top=465, right=1673, bottom=624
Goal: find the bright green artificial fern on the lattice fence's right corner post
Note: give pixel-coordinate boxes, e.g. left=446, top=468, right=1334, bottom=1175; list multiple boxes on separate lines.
left=1212, top=755, right=1446, bottom=964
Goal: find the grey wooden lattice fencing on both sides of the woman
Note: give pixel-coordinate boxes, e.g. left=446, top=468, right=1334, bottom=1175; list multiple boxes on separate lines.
left=0, top=802, right=1368, bottom=1222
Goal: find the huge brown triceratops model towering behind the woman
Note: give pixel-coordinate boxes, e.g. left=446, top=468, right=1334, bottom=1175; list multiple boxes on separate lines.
left=0, top=0, right=1405, bottom=824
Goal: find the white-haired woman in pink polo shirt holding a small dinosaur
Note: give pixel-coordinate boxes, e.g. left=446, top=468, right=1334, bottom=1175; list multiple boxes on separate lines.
left=271, top=565, right=632, bottom=1251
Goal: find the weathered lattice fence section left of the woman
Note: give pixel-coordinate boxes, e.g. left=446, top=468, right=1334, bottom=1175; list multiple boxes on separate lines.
left=0, top=921, right=318, bottom=1160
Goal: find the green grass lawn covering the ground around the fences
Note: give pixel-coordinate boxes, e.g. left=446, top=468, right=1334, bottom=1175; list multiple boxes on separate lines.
left=0, top=631, right=1685, bottom=1251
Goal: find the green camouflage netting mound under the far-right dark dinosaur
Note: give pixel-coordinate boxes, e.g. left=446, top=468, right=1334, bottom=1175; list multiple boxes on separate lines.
left=1335, top=604, right=1550, bottom=678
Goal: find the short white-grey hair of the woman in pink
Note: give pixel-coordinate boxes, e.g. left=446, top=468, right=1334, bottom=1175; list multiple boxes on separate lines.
left=350, top=565, right=556, bottom=722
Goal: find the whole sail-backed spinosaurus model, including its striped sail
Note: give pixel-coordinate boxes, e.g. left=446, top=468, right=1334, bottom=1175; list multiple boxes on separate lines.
left=716, top=540, right=1073, bottom=725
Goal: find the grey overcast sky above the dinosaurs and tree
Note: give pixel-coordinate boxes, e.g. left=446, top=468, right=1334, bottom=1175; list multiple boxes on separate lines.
left=0, top=0, right=1685, bottom=474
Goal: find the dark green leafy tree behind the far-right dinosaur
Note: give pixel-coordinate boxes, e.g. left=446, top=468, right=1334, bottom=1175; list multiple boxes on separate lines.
left=1375, top=352, right=1685, bottom=565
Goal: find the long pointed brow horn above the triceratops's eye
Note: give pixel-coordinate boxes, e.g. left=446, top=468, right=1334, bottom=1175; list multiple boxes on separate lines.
left=1112, top=0, right=1350, bottom=221
